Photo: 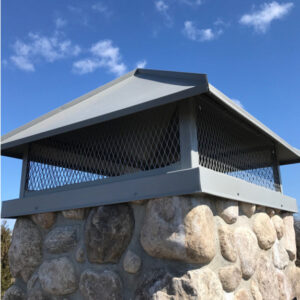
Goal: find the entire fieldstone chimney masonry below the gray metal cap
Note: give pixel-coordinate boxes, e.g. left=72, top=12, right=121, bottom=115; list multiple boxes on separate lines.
left=4, top=196, right=300, bottom=300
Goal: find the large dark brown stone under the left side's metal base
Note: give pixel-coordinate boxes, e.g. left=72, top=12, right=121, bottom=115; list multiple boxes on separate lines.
left=85, top=204, right=134, bottom=263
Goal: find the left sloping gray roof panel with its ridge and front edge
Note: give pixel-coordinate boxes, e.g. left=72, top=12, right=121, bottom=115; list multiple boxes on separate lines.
left=2, top=69, right=208, bottom=155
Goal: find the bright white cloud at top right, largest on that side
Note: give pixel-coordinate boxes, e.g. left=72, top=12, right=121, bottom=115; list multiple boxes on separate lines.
left=240, top=1, right=294, bottom=33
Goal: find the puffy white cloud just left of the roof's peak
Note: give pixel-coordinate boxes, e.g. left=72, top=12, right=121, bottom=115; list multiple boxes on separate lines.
left=73, top=40, right=127, bottom=76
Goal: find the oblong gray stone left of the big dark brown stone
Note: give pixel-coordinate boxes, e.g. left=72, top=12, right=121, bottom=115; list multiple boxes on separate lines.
left=44, top=226, right=77, bottom=253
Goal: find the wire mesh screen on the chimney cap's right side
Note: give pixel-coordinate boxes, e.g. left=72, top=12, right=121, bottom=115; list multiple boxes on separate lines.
left=197, top=96, right=280, bottom=191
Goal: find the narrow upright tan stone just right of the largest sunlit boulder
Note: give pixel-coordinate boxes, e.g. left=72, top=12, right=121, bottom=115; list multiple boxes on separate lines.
left=218, top=224, right=237, bottom=262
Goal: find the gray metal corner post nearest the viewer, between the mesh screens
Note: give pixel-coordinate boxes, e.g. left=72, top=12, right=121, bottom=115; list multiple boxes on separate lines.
left=179, top=98, right=199, bottom=169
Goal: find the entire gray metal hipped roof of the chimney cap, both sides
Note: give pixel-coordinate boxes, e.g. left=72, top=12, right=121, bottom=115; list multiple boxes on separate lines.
left=1, top=69, right=300, bottom=164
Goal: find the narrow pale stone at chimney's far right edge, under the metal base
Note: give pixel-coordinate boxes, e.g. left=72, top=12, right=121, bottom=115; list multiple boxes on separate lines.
left=283, top=214, right=297, bottom=261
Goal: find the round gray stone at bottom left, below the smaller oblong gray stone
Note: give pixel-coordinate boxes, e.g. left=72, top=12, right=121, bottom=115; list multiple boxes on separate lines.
left=38, top=257, right=77, bottom=295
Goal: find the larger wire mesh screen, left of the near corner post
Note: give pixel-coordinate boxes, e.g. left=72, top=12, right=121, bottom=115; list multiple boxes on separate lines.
left=25, top=105, right=180, bottom=191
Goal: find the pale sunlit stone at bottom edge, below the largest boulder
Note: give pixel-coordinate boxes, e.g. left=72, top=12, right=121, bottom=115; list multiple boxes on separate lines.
left=188, top=268, right=224, bottom=300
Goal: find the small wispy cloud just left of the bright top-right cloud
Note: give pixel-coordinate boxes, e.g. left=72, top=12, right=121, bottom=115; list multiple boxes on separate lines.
left=183, top=21, right=222, bottom=42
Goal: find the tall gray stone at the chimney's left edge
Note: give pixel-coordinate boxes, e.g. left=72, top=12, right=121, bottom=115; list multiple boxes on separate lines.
left=8, top=218, right=42, bottom=282
